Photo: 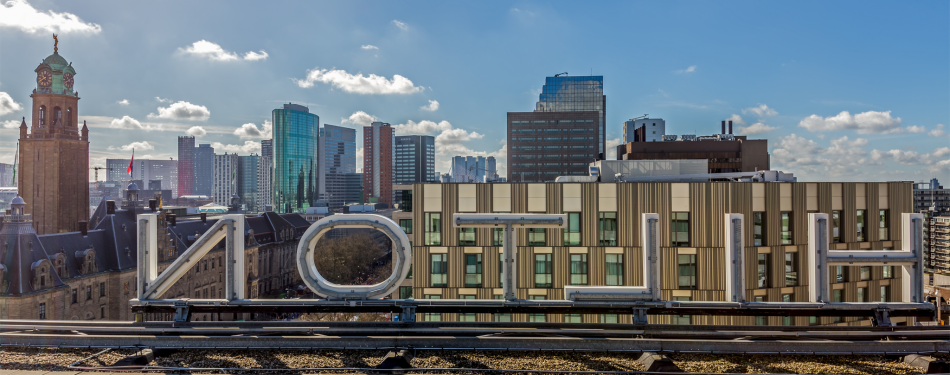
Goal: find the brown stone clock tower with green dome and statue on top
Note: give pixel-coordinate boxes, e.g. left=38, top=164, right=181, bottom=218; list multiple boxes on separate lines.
left=17, top=34, right=89, bottom=234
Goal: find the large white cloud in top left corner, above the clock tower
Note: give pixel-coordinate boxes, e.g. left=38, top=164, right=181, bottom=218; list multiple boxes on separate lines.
left=0, top=0, right=102, bottom=34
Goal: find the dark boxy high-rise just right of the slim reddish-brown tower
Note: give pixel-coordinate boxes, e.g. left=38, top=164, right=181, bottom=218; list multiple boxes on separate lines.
left=393, top=135, right=436, bottom=185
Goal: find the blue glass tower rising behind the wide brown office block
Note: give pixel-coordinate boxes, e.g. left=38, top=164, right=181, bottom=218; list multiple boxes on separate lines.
left=534, top=76, right=607, bottom=159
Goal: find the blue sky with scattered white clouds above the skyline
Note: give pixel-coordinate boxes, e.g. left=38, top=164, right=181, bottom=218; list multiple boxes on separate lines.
left=0, top=0, right=950, bottom=185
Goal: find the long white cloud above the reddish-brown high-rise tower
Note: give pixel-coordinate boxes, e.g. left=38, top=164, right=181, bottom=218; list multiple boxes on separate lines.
left=294, top=68, right=424, bottom=94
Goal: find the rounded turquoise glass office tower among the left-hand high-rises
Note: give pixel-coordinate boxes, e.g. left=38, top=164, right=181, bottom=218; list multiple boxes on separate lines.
left=271, top=104, right=320, bottom=213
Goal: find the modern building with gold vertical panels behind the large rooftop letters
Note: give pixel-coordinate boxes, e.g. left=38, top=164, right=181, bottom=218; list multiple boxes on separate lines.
left=393, top=182, right=912, bottom=325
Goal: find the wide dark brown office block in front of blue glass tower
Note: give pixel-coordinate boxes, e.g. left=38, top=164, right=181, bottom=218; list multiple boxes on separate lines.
left=507, top=111, right=601, bottom=182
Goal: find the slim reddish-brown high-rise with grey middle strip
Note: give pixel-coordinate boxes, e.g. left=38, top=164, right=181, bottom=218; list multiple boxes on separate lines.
left=363, top=121, right=396, bottom=207
